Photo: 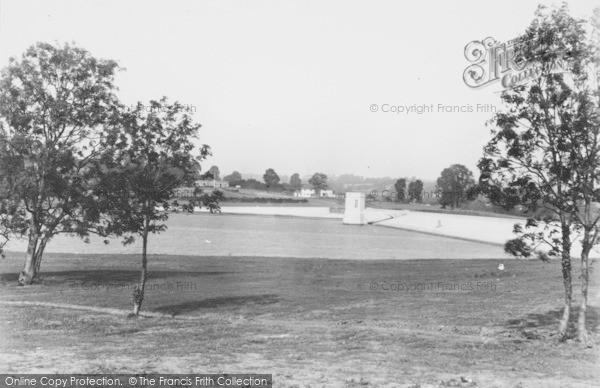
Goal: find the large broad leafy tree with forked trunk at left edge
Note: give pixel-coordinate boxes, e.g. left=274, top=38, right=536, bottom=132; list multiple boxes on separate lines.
left=0, top=43, right=121, bottom=285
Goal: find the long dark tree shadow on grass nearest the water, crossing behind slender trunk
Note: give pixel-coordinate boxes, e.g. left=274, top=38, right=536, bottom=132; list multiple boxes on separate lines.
left=0, top=269, right=233, bottom=285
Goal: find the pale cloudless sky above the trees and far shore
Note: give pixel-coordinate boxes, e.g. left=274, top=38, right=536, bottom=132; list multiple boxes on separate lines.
left=0, top=0, right=600, bottom=180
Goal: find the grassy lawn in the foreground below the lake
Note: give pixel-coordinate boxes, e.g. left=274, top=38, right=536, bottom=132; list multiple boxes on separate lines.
left=0, top=254, right=600, bottom=387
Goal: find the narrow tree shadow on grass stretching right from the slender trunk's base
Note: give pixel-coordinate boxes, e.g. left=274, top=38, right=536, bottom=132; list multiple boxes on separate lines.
left=154, top=294, right=280, bottom=316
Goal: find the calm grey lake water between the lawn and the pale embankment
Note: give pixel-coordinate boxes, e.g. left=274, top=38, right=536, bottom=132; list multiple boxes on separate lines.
left=6, top=214, right=506, bottom=260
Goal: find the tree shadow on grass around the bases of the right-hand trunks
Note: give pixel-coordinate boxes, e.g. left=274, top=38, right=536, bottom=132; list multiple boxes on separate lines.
left=504, top=306, right=600, bottom=334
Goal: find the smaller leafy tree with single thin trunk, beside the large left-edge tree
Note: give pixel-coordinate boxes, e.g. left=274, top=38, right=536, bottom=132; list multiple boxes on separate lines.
left=96, top=98, right=222, bottom=316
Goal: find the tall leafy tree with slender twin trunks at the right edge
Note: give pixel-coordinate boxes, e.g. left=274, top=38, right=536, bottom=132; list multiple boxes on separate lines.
left=479, top=5, right=600, bottom=342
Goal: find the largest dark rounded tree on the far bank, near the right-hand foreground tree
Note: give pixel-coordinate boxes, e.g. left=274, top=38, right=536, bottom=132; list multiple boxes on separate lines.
left=436, top=164, right=475, bottom=209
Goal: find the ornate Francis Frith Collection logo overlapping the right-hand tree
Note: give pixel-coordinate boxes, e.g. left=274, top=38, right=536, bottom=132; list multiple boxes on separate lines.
left=463, top=37, right=565, bottom=88
